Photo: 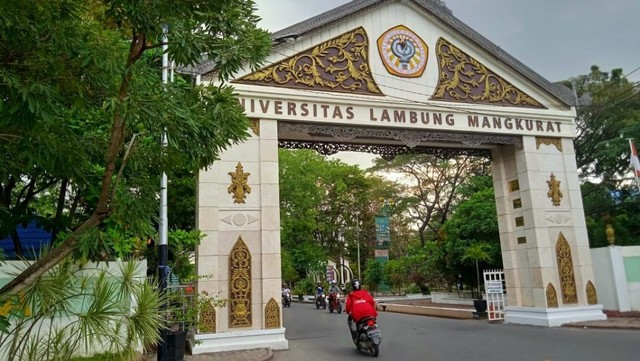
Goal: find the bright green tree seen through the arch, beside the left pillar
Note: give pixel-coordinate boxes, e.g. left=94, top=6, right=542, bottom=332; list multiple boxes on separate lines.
left=279, top=149, right=392, bottom=281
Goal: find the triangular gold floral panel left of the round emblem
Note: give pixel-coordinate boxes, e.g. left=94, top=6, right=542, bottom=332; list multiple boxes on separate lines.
left=234, top=27, right=383, bottom=95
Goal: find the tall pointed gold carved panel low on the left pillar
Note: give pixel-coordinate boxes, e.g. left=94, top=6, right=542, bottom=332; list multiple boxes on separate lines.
left=229, top=237, right=251, bottom=327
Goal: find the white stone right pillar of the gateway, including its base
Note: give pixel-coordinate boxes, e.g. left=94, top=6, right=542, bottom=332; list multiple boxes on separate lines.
left=492, top=136, right=606, bottom=326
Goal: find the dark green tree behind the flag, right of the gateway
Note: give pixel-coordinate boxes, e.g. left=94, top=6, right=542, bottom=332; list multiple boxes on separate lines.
left=564, top=65, right=640, bottom=247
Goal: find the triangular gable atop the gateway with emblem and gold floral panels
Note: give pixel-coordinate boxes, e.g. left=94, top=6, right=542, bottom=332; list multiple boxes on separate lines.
left=229, top=0, right=571, bottom=109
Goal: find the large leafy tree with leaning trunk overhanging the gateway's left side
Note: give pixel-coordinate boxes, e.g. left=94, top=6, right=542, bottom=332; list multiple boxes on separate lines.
left=0, top=0, right=271, bottom=294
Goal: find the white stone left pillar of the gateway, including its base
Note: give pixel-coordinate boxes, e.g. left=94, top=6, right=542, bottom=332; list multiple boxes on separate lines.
left=192, top=120, right=289, bottom=354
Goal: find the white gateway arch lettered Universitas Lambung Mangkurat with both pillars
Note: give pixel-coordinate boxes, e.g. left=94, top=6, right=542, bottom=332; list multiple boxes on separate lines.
left=185, top=0, right=606, bottom=353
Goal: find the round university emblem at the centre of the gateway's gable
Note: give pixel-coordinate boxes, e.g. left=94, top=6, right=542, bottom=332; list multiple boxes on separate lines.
left=378, top=25, right=429, bottom=78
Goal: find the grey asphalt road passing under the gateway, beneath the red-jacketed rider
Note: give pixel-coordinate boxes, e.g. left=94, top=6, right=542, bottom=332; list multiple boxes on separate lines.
left=273, top=303, right=640, bottom=361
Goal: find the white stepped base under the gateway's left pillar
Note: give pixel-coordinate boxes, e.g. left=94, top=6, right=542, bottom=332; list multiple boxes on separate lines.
left=189, top=327, right=289, bottom=355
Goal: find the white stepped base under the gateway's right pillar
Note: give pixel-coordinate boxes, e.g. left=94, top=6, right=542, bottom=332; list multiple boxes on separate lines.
left=504, top=305, right=607, bottom=327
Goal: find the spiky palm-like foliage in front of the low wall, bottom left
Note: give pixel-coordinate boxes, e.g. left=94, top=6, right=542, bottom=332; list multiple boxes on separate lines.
left=0, top=261, right=163, bottom=361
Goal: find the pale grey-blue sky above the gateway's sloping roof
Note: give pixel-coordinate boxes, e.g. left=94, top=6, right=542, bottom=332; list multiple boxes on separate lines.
left=255, top=0, right=640, bottom=166
